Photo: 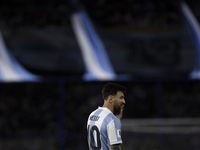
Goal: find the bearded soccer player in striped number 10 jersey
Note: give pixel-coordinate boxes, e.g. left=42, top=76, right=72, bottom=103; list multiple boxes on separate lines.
left=87, top=83, right=126, bottom=150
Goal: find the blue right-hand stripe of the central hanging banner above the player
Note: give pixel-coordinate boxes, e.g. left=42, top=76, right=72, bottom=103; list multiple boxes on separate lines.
left=79, top=11, right=114, bottom=74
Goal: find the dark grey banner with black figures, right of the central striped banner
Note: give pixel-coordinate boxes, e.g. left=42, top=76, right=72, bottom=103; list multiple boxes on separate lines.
left=101, top=30, right=195, bottom=78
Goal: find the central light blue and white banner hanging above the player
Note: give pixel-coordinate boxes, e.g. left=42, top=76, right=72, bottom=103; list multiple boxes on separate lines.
left=71, top=10, right=116, bottom=81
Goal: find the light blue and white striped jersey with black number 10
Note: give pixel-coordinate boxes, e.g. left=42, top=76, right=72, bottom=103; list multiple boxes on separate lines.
left=87, top=107, right=122, bottom=150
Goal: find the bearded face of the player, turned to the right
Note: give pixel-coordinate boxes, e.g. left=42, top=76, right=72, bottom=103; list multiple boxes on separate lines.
left=113, top=91, right=126, bottom=115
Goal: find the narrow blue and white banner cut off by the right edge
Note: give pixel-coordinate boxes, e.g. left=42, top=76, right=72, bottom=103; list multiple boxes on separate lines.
left=181, top=2, right=200, bottom=79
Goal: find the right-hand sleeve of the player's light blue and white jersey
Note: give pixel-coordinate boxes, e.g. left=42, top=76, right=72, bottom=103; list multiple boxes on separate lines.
left=107, top=119, right=122, bottom=145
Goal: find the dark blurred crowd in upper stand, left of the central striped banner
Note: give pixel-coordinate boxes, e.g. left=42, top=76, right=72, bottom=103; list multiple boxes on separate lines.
left=0, top=0, right=71, bottom=28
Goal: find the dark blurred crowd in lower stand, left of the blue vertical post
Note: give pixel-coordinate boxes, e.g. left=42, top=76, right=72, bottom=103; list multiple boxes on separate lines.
left=0, top=83, right=59, bottom=137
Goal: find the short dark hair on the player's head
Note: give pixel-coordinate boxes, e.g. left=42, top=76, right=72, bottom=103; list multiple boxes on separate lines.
left=102, top=83, right=126, bottom=100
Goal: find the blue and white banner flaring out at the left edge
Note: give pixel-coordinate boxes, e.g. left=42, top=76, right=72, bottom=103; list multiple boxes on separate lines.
left=0, top=32, right=40, bottom=82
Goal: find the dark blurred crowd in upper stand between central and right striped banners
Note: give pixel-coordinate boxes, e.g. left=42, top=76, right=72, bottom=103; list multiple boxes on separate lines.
left=87, top=0, right=182, bottom=27
